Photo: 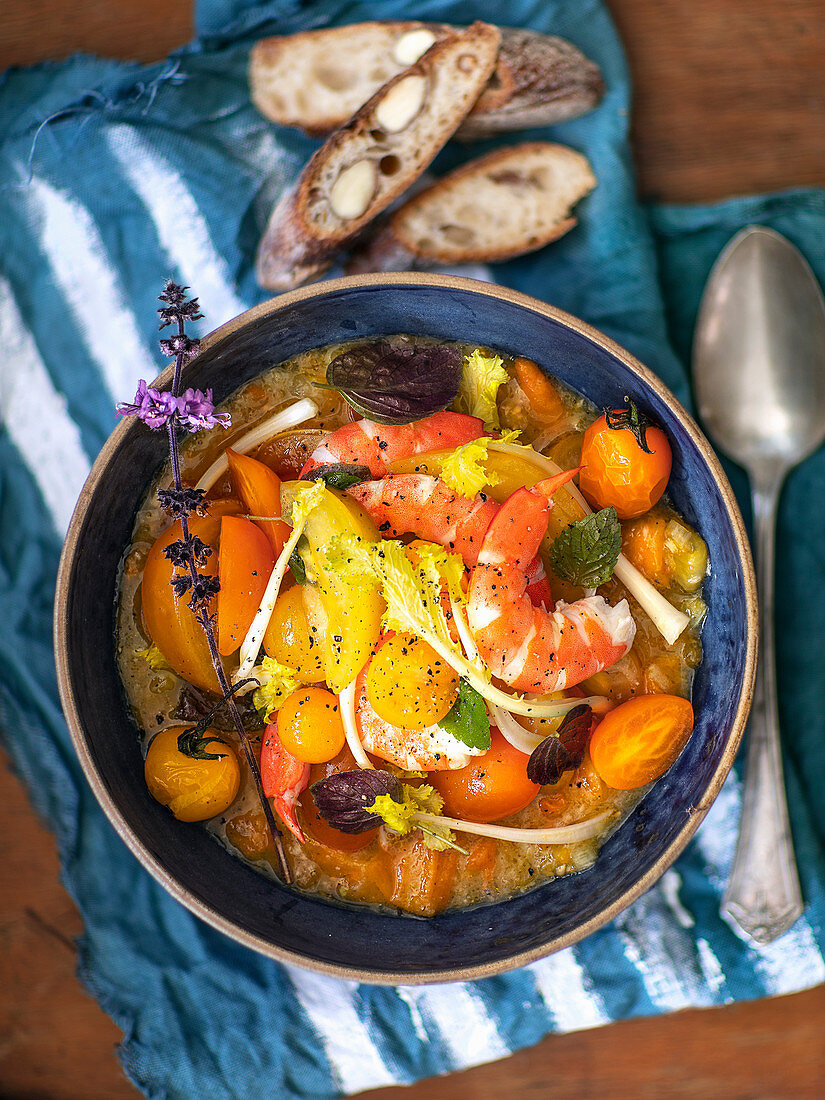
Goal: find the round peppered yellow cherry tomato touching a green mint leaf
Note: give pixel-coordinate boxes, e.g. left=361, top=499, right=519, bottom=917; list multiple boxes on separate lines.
left=366, top=634, right=459, bottom=729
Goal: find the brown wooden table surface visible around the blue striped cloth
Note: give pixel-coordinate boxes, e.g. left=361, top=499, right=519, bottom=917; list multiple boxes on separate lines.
left=0, top=0, right=825, bottom=1100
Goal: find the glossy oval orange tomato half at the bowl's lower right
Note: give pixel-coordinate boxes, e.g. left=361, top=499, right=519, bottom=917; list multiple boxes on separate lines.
left=590, top=695, right=693, bottom=791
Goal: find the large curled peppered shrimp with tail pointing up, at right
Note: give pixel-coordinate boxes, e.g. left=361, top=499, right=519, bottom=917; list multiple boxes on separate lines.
left=468, top=477, right=636, bottom=694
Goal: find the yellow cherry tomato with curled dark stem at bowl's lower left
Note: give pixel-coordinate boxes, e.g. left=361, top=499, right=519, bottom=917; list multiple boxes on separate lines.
left=144, top=726, right=241, bottom=822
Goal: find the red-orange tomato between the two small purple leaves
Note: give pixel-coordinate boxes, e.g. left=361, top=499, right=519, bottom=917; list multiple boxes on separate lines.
left=428, top=729, right=540, bottom=822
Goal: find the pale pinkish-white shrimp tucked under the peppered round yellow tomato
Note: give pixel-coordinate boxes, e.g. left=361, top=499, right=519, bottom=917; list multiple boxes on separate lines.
left=355, top=666, right=483, bottom=771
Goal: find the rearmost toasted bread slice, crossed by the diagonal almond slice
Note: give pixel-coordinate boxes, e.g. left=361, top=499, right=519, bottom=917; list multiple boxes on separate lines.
left=249, top=21, right=604, bottom=140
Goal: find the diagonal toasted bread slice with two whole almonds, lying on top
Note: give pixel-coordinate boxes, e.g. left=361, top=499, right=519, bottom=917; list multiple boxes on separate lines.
left=256, top=23, right=499, bottom=290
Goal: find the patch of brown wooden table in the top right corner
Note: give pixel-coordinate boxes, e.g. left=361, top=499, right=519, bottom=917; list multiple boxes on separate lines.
left=608, top=0, right=825, bottom=202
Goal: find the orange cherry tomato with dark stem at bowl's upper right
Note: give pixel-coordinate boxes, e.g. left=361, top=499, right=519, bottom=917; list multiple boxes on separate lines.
left=579, top=402, right=672, bottom=519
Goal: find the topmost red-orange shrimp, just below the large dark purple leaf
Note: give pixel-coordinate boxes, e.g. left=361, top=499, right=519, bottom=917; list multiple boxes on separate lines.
left=300, top=411, right=484, bottom=477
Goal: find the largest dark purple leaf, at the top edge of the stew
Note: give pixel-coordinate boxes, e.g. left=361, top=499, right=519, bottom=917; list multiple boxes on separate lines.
left=327, top=340, right=462, bottom=424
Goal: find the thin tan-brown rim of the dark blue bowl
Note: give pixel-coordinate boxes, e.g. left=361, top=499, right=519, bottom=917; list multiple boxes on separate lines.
left=54, top=272, right=758, bottom=986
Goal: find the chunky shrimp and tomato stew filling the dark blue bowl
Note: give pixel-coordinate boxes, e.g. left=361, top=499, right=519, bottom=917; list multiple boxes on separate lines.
left=118, top=336, right=707, bottom=916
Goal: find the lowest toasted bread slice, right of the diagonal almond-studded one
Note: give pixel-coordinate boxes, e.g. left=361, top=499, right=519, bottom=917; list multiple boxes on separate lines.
left=347, top=142, right=596, bottom=274
